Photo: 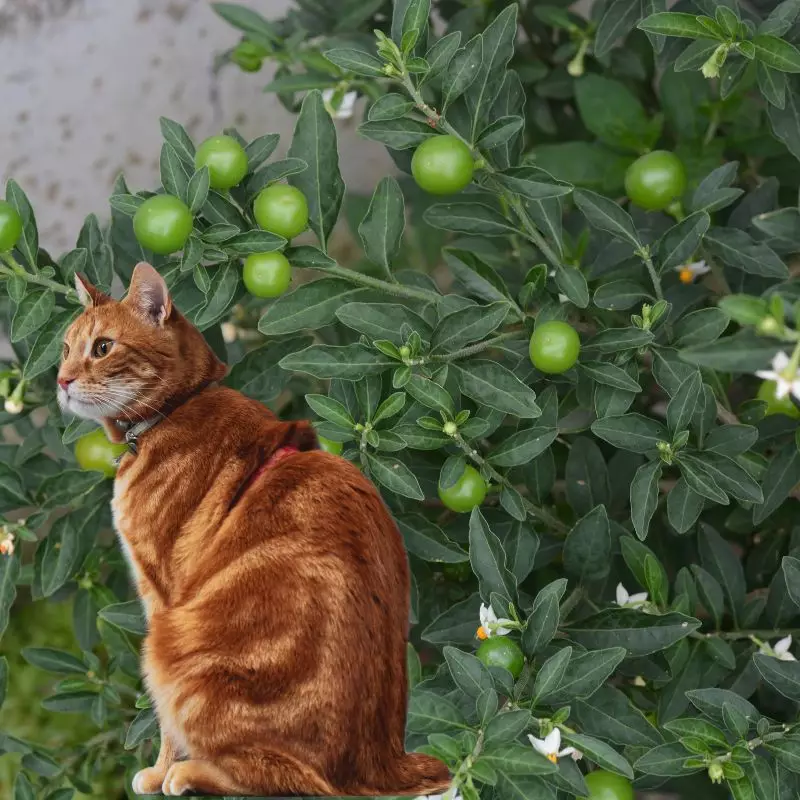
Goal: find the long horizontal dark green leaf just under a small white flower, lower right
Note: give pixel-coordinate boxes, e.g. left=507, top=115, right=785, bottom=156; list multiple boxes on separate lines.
left=567, top=608, right=700, bottom=658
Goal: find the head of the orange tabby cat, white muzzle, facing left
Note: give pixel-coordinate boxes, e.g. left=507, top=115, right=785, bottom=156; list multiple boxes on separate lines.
left=58, top=263, right=226, bottom=423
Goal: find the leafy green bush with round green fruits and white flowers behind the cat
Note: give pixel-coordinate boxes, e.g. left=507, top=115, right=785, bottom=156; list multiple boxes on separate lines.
left=0, top=0, right=800, bottom=800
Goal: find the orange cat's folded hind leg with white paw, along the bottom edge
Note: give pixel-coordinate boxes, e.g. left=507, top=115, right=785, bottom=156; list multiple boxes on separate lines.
left=161, top=750, right=338, bottom=797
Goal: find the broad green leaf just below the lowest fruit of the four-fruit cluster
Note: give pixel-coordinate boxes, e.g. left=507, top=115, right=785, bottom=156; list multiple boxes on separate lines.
left=258, top=278, right=368, bottom=336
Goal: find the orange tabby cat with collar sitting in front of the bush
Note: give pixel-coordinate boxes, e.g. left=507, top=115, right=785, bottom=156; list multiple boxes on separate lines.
left=58, top=264, right=449, bottom=795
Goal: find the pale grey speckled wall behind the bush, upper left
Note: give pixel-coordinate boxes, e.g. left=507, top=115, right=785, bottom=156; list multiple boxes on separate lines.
left=0, top=0, right=392, bottom=255
